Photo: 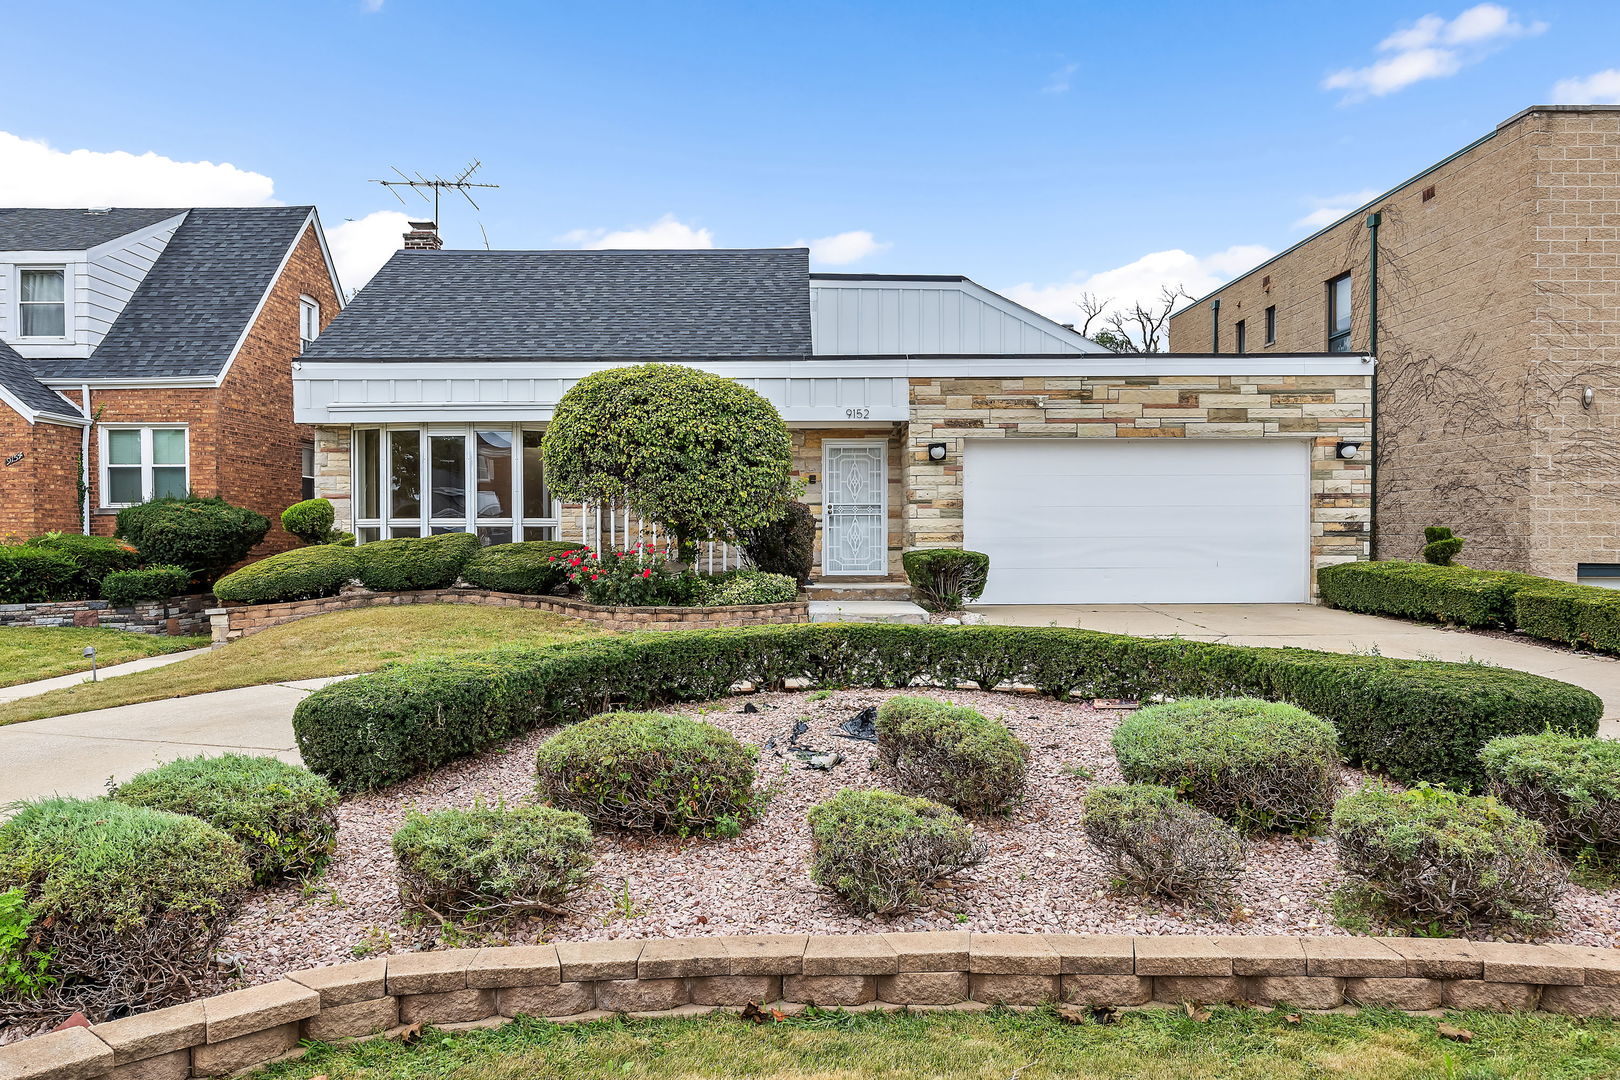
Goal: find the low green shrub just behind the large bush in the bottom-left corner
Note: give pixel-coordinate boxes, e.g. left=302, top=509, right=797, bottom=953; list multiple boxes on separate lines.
left=112, top=755, right=337, bottom=886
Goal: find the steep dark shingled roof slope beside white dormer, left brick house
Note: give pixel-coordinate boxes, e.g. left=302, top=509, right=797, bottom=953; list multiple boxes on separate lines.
left=43, top=206, right=313, bottom=379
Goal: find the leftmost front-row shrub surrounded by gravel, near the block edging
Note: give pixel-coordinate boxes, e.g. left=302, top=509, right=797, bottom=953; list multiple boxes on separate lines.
left=394, top=805, right=591, bottom=923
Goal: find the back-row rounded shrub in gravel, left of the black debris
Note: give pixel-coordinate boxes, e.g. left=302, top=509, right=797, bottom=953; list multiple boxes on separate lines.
left=536, top=712, right=761, bottom=834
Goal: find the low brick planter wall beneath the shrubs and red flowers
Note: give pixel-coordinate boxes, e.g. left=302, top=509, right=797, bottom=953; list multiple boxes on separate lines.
left=209, top=588, right=810, bottom=644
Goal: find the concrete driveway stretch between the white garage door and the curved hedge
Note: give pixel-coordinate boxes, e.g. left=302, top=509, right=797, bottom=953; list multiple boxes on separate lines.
left=974, top=604, right=1620, bottom=738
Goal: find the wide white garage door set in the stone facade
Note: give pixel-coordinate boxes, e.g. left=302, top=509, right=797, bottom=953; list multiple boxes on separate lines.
left=962, top=439, right=1311, bottom=604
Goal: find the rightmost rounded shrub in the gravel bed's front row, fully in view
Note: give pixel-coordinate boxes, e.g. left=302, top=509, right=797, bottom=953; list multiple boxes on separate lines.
left=1333, top=782, right=1565, bottom=928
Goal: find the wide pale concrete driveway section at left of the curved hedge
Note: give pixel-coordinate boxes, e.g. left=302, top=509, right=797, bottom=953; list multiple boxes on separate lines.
left=0, top=678, right=337, bottom=805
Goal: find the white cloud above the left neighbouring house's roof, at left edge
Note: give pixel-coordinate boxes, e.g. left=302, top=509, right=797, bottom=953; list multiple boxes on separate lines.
left=0, top=131, right=275, bottom=207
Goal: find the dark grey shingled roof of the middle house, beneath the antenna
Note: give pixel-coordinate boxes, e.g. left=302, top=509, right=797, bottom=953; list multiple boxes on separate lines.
left=303, top=248, right=810, bottom=361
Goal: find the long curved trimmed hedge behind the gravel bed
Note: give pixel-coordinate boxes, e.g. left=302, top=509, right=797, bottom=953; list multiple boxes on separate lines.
left=293, top=623, right=1602, bottom=790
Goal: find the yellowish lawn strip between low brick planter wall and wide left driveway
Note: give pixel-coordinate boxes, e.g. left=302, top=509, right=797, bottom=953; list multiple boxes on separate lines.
left=0, top=604, right=601, bottom=724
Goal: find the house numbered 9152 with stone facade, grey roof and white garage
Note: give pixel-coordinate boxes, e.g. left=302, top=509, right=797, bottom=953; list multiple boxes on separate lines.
left=293, top=230, right=1371, bottom=604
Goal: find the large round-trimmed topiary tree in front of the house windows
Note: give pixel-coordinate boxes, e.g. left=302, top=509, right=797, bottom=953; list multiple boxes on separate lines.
left=541, top=364, right=794, bottom=560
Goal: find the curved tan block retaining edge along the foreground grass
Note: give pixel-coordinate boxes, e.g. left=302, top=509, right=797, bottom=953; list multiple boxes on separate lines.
left=0, top=931, right=1620, bottom=1080
